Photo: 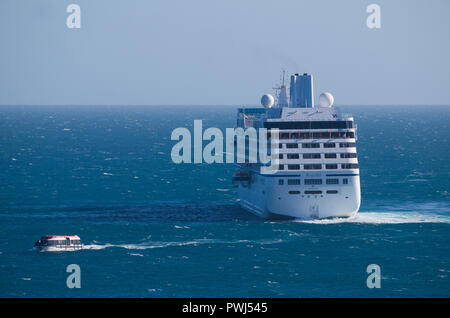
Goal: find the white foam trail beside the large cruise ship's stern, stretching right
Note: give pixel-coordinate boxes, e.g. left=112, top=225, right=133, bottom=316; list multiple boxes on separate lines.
left=294, top=212, right=450, bottom=224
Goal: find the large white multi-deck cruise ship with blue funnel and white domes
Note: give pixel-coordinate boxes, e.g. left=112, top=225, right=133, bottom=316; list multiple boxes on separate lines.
left=233, top=73, right=361, bottom=219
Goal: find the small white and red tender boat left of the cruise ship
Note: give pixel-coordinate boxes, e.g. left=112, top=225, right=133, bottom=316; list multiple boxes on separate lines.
left=34, top=235, right=83, bottom=252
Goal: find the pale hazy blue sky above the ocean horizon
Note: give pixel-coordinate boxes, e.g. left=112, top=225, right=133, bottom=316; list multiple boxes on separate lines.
left=0, top=0, right=450, bottom=105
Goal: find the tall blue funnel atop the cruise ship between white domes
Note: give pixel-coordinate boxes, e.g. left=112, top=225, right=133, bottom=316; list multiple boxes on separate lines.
left=289, top=73, right=314, bottom=108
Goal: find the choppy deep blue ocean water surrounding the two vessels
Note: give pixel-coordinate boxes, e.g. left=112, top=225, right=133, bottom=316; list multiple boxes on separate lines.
left=0, top=106, right=450, bottom=297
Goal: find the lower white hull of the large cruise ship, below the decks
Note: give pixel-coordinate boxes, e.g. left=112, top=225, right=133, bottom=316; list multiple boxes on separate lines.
left=237, top=172, right=361, bottom=219
